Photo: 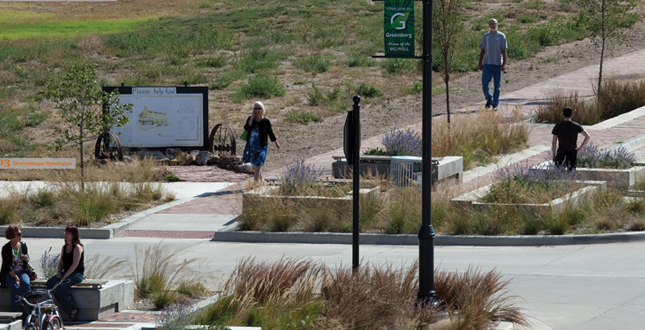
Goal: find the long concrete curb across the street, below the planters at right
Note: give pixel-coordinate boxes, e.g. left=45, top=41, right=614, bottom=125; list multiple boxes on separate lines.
left=211, top=231, right=645, bottom=246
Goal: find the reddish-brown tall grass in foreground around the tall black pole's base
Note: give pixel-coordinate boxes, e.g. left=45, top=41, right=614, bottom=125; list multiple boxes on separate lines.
left=198, top=258, right=526, bottom=330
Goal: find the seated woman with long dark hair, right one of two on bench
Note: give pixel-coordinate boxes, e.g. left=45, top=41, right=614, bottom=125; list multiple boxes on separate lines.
left=47, top=226, right=85, bottom=322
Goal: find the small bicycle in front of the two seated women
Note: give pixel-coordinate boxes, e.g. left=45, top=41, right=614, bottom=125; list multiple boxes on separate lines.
left=16, top=280, right=69, bottom=330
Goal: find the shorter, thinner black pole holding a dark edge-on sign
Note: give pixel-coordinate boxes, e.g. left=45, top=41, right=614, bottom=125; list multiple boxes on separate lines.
left=352, top=95, right=361, bottom=271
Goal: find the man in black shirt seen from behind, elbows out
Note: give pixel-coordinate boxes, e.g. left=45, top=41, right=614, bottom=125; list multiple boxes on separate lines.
left=551, top=107, right=591, bottom=171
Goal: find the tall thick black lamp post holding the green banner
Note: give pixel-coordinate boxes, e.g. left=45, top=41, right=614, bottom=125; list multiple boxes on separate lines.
left=417, top=0, right=436, bottom=305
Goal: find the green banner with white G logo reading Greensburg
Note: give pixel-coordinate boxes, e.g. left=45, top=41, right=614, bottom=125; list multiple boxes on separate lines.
left=384, top=0, right=414, bottom=58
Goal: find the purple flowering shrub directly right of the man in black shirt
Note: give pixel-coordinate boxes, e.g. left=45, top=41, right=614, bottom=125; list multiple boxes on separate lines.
left=577, top=143, right=636, bottom=169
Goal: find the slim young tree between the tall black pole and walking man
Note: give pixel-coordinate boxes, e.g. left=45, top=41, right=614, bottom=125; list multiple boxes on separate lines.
left=432, top=0, right=467, bottom=123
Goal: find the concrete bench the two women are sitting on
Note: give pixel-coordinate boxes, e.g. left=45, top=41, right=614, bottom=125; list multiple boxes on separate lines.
left=0, top=279, right=134, bottom=321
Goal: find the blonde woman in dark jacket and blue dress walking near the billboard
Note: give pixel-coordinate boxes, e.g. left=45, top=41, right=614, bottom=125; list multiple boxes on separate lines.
left=242, top=101, right=280, bottom=183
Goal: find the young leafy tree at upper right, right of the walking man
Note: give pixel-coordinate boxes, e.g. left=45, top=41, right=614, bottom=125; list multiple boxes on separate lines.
left=575, top=0, right=636, bottom=102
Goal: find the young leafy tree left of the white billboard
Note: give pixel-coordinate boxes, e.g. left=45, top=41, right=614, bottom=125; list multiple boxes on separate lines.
left=44, top=65, right=132, bottom=191
